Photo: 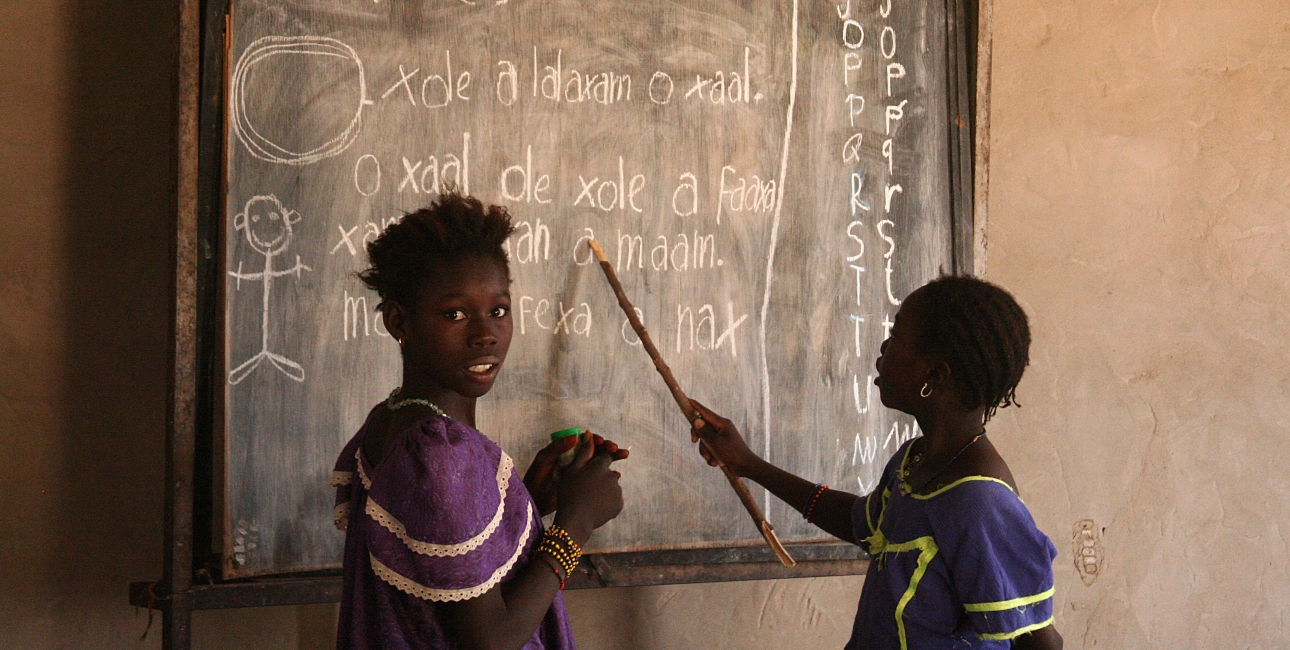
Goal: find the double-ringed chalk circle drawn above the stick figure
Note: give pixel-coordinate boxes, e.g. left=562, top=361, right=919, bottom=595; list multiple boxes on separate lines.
left=228, top=36, right=373, bottom=165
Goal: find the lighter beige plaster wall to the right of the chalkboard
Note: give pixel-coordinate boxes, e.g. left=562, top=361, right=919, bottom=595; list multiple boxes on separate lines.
left=986, top=0, right=1290, bottom=649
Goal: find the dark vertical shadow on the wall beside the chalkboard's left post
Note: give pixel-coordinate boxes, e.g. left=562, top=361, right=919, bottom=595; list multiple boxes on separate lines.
left=43, top=0, right=177, bottom=647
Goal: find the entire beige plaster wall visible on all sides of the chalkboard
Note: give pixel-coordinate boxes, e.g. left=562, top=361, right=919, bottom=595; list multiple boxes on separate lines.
left=0, top=0, right=1290, bottom=650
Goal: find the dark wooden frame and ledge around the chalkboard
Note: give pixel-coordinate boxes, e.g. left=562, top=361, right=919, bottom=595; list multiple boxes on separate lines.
left=129, top=0, right=989, bottom=650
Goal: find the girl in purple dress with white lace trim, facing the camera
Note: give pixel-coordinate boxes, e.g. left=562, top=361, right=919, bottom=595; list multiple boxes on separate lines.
left=332, top=195, right=627, bottom=650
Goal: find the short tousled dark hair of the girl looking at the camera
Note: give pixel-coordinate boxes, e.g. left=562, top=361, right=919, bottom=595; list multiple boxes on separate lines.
left=359, top=192, right=515, bottom=310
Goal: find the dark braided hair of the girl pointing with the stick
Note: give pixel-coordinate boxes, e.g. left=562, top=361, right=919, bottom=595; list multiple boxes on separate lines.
left=916, top=276, right=1031, bottom=422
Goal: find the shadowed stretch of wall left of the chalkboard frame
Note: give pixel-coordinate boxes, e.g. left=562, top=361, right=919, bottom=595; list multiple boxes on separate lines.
left=0, top=0, right=173, bottom=649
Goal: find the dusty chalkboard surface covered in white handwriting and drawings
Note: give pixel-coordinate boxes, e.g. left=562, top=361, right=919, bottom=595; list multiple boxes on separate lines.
left=215, top=0, right=952, bottom=576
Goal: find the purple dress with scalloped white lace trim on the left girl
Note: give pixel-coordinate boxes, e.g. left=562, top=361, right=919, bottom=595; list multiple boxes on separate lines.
left=332, top=406, right=575, bottom=650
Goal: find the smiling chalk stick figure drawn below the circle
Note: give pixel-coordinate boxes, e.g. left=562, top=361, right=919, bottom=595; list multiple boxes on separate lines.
left=228, top=195, right=312, bottom=384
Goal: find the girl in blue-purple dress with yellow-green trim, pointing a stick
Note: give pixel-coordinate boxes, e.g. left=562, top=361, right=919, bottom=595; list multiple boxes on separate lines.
left=694, top=277, right=1062, bottom=650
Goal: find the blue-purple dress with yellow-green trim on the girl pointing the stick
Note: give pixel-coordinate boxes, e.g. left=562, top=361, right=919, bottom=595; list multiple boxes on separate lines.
left=846, top=441, right=1057, bottom=650
